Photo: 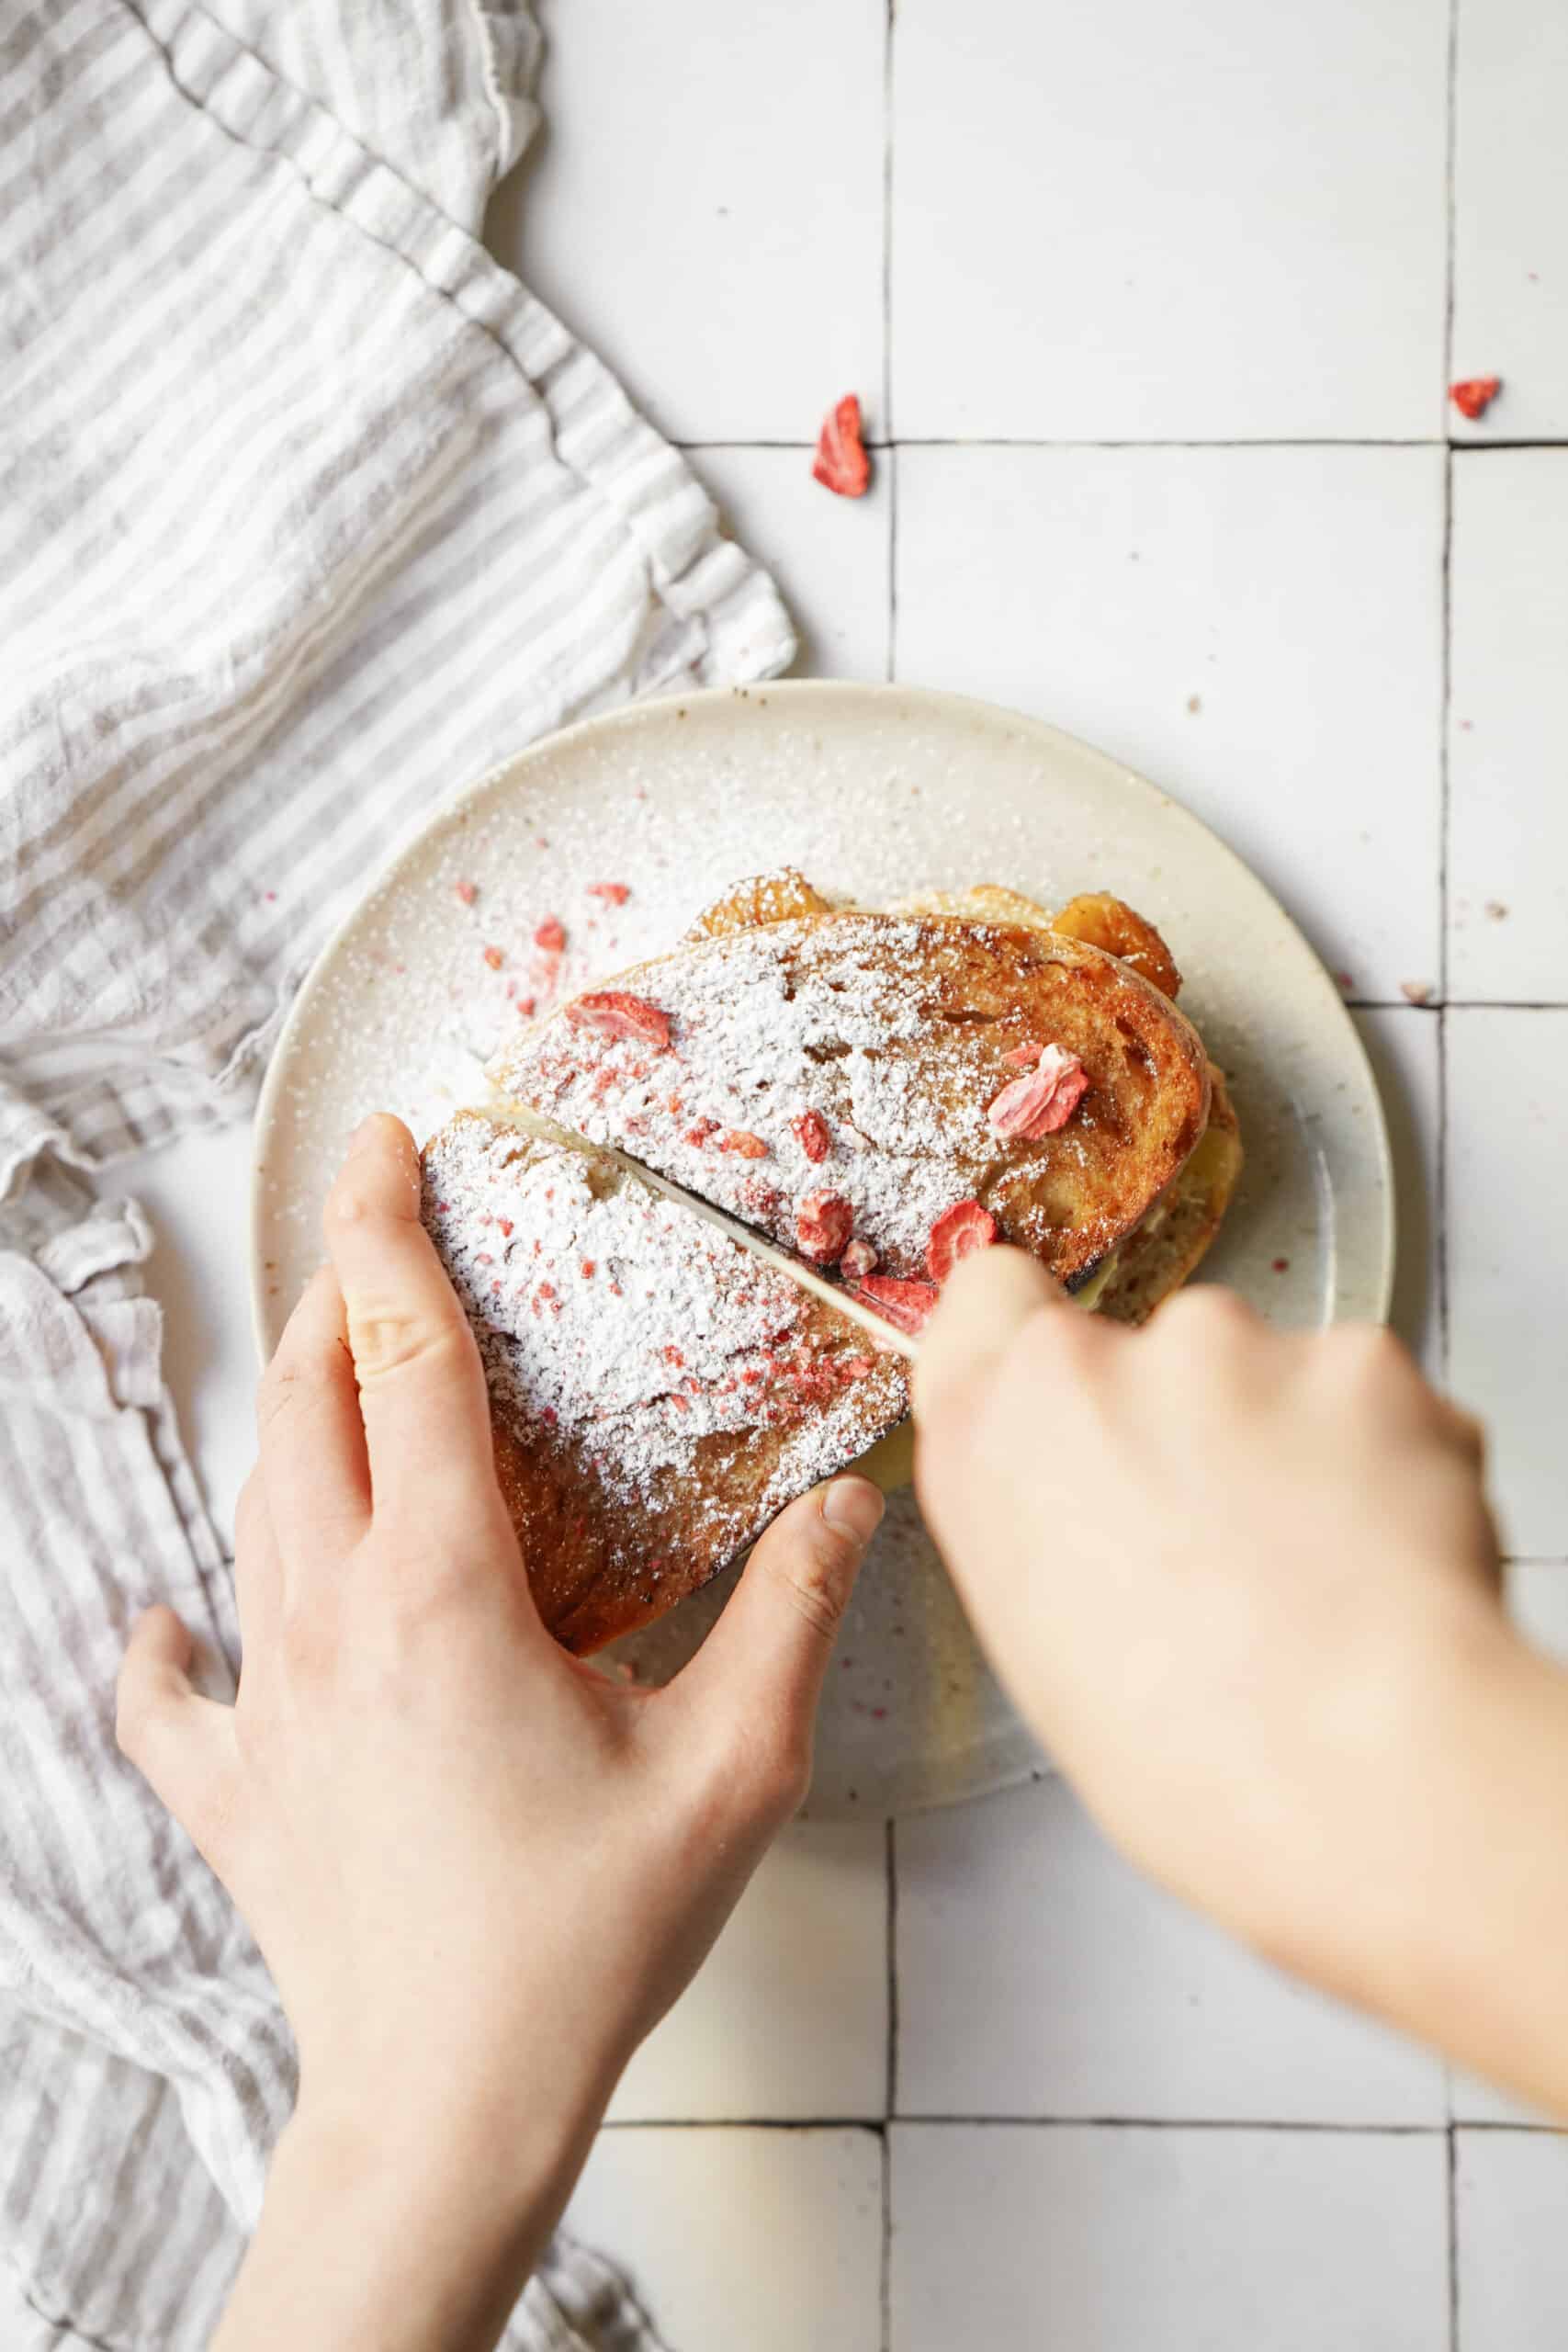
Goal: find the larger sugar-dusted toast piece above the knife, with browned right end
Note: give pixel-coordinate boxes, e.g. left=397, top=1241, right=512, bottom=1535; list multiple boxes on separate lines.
left=489, top=912, right=1208, bottom=1298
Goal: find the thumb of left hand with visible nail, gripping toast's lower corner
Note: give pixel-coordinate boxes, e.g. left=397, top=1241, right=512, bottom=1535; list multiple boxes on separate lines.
left=677, top=1477, right=884, bottom=1757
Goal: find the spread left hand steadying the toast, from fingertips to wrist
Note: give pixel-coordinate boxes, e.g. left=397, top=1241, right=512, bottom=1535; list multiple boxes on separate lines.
left=120, top=1117, right=882, bottom=2340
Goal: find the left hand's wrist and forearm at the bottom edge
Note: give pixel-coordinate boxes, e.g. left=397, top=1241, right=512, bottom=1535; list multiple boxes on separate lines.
left=214, top=2084, right=604, bottom=2352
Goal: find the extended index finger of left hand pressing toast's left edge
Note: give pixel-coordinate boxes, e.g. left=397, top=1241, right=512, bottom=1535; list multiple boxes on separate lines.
left=324, top=1113, right=496, bottom=1515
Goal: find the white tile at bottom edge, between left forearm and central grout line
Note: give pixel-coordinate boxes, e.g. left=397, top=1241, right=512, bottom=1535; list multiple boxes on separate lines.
left=567, top=2126, right=882, bottom=2352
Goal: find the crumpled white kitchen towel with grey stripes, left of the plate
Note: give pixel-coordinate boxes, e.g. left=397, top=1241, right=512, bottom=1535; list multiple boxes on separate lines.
left=0, top=0, right=792, bottom=2352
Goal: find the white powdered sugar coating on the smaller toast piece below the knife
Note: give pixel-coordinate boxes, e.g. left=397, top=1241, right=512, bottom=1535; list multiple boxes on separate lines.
left=425, top=1117, right=908, bottom=1523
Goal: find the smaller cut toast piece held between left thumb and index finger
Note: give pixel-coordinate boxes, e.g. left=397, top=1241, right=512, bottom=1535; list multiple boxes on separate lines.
left=423, top=1110, right=909, bottom=1656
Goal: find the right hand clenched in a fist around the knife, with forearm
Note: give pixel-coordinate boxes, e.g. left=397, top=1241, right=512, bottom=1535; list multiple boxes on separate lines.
left=917, top=1249, right=1568, bottom=2098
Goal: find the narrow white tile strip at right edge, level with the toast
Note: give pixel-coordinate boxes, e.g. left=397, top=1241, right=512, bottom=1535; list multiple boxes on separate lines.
left=1446, top=1009, right=1568, bottom=1559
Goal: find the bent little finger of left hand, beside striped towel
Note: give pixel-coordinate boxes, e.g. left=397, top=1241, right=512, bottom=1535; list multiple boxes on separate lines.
left=115, top=1606, right=240, bottom=1870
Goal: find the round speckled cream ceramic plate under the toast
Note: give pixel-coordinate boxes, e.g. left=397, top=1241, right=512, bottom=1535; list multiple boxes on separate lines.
left=254, top=682, right=1394, bottom=1815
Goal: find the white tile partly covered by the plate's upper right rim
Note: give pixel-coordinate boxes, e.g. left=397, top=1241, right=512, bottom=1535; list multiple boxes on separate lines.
left=894, top=449, right=1443, bottom=1002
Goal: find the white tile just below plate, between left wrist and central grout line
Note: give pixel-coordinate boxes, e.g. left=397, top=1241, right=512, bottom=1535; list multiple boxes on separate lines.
left=609, top=1820, right=886, bottom=2121
